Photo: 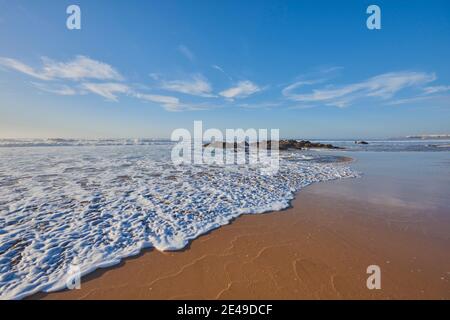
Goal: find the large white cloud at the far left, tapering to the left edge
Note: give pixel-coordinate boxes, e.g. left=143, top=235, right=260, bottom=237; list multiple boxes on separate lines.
left=0, top=55, right=123, bottom=81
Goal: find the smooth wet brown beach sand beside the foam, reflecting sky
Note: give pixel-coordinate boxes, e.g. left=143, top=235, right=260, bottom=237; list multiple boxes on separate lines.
left=30, top=151, right=450, bottom=299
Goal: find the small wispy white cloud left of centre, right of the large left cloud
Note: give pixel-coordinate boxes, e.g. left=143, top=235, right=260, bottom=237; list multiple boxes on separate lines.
left=161, top=74, right=214, bottom=97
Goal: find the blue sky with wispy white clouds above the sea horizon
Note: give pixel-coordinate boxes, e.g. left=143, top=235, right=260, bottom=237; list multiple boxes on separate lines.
left=0, top=0, right=450, bottom=138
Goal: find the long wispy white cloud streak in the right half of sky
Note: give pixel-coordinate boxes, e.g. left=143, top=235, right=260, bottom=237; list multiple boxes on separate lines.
left=282, top=72, right=436, bottom=107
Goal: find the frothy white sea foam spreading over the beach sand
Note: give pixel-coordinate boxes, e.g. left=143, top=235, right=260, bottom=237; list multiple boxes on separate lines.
left=0, top=143, right=355, bottom=299
